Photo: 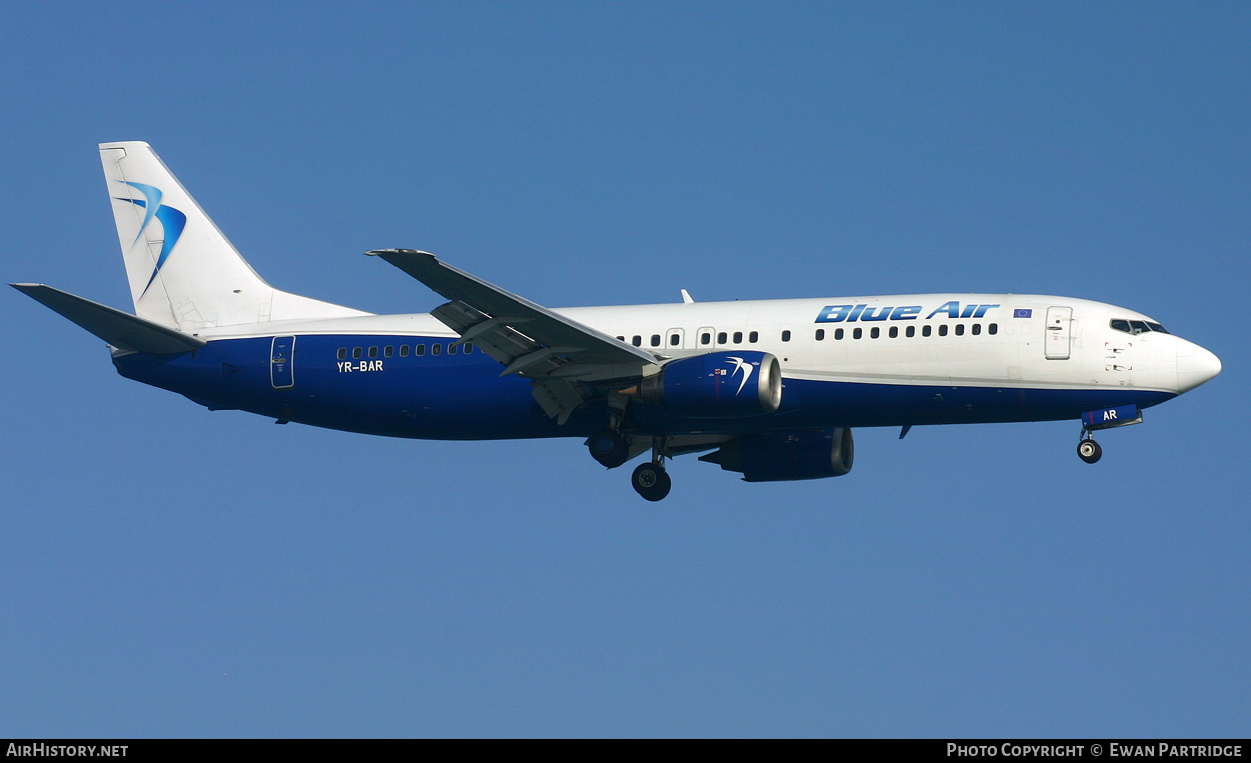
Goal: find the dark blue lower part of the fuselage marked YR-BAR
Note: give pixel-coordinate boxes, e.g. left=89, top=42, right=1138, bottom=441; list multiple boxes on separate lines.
left=114, top=335, right=1175, bottom=440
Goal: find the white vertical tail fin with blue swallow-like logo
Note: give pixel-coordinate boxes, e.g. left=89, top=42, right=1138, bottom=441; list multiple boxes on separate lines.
left=100, top=141, right=364, bottom=333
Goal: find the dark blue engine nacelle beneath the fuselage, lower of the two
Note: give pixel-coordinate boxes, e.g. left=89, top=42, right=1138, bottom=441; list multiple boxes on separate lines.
left=699, top=429, right=856, bottom=482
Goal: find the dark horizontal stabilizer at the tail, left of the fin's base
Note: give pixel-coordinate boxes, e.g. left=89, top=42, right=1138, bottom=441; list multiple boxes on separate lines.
left=9, top=284, right=205, bottom=354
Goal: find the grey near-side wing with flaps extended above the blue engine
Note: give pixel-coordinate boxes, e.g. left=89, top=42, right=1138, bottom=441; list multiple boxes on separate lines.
left=365, top=249, right=662, bottom=423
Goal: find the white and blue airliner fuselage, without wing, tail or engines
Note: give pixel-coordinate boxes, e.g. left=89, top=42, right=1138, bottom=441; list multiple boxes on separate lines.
left=114, top=294, right=1218, bottom=439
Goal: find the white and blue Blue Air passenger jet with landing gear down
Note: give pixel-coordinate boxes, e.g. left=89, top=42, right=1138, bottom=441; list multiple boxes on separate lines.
left=10, top=141, right=1221, bottom=502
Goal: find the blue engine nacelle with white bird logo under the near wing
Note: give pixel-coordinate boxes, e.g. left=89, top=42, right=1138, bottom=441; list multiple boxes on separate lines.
left=637, top=350, right=782, bottom=419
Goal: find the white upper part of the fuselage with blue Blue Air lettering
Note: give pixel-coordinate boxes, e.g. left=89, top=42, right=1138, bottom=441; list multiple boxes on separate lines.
left=198, top=294, right=1221, bottom=394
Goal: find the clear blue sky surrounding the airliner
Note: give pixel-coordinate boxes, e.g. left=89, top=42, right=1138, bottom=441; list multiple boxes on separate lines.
left=0, top=3, right=1251, bottom=737
